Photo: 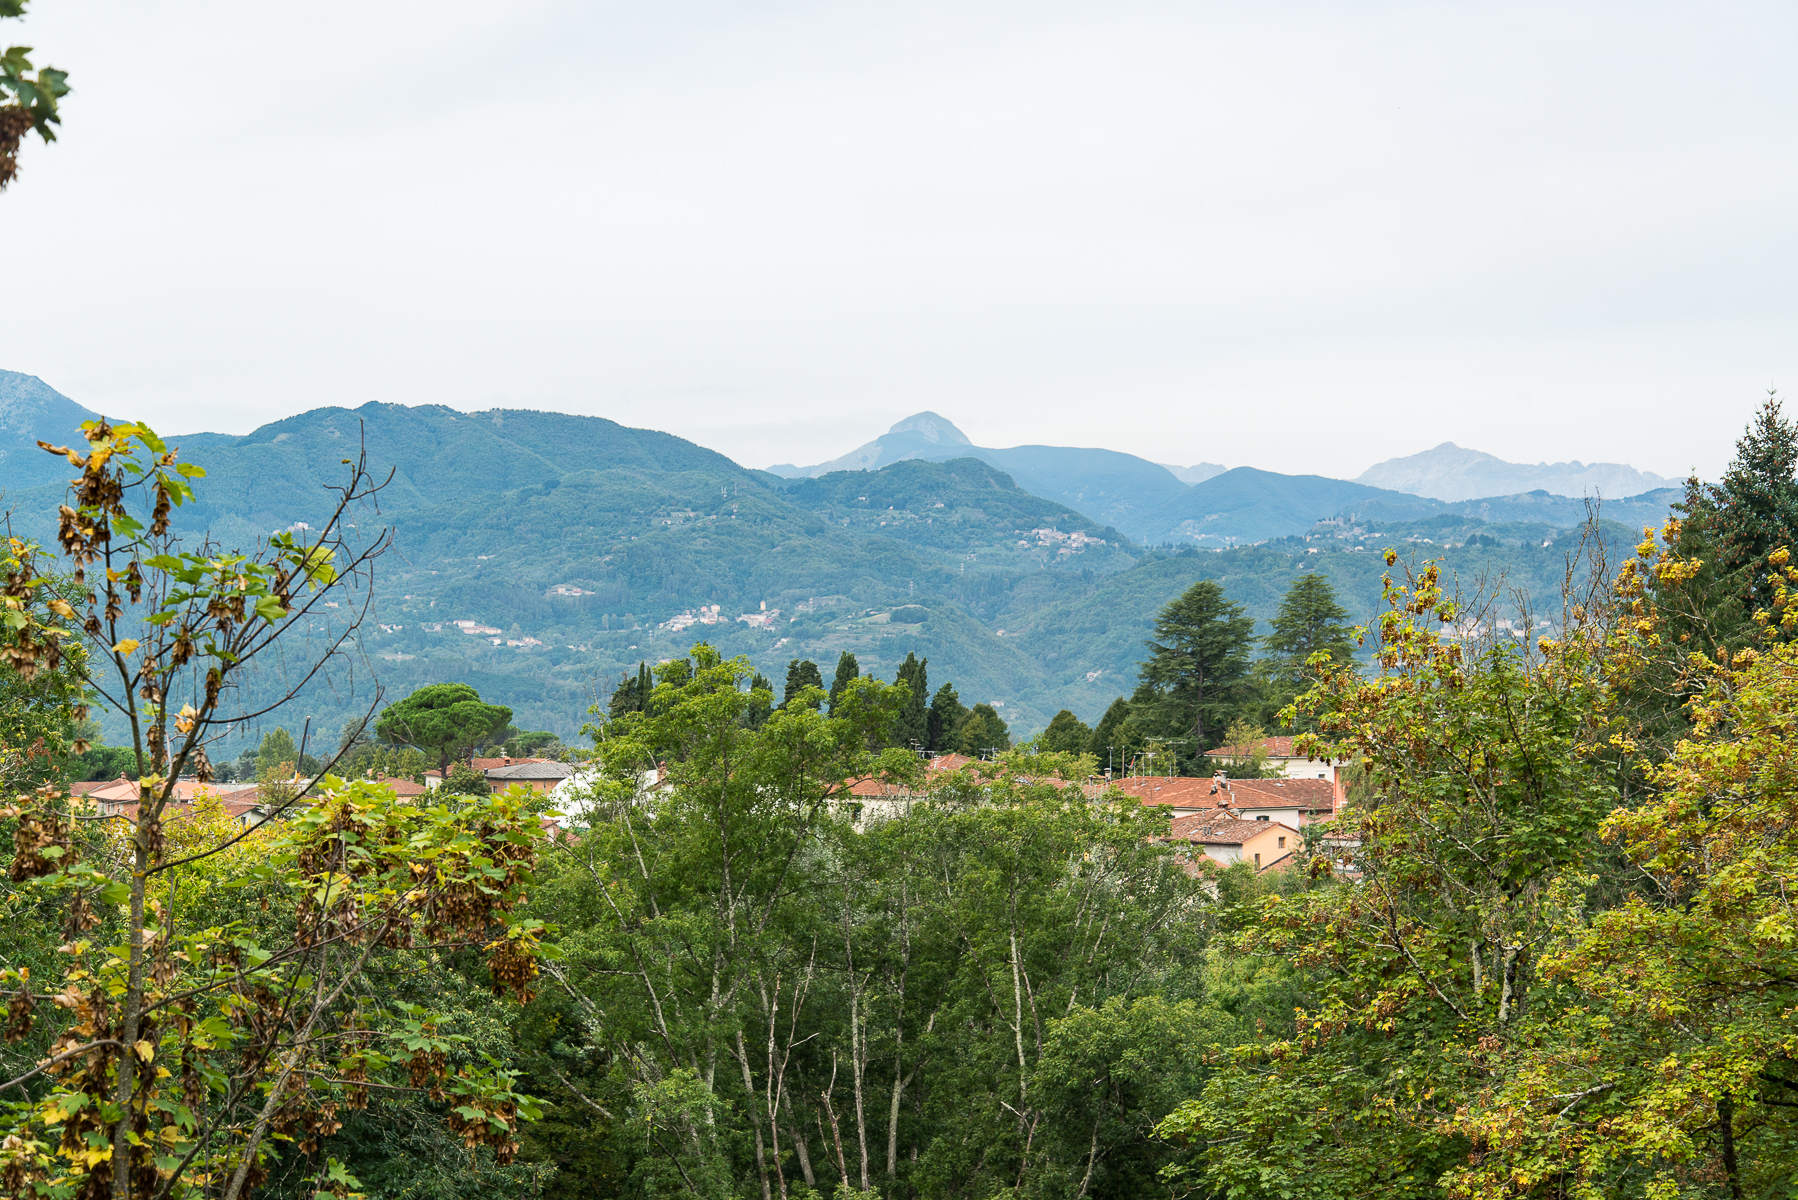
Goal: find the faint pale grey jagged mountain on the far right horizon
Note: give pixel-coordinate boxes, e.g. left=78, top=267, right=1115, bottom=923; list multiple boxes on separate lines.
left=1356, top=441, right=1678, bottom=500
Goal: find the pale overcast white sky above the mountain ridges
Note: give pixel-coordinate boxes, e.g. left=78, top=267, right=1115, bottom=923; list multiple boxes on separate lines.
left=0, top=0, right=1798, bottom=477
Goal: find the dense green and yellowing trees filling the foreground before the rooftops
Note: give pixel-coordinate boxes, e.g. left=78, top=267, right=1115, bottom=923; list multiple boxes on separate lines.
left=0, top=401, right=1798, bottom=1200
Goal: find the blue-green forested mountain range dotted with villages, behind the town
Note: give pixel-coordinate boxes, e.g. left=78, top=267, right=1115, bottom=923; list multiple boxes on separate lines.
left=0, top=372, right=1674, bottom=738
